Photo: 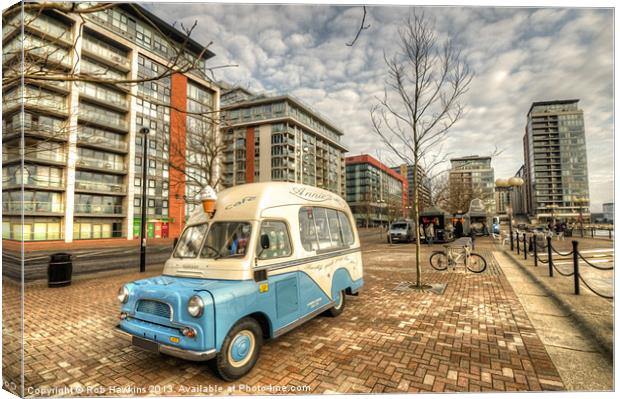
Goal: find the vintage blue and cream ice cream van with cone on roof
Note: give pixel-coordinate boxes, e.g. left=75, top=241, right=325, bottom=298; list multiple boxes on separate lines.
left=116, top=182, right=363, bottom=381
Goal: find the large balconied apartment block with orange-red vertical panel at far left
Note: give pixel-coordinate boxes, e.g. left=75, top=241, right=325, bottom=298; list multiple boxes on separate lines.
left=2, top=3, right=219, bottom=242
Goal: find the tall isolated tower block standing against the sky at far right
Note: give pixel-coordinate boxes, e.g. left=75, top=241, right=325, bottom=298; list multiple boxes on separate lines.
left=523, top=100, right=590, bottom=221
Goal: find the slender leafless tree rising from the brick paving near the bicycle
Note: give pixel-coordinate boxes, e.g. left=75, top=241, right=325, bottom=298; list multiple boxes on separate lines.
left=370, top=12, right=473, bottom=289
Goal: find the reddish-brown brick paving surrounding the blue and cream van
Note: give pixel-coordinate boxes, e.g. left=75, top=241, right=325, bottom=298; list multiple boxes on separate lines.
left=3, top=238, right=564, bottom=396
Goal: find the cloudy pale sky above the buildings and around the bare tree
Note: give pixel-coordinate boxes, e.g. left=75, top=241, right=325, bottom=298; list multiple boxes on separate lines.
left=145, top=3, right=614, bottom=212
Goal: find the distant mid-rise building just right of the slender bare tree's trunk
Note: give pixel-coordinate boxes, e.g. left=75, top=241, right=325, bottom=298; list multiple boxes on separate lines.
left=448, top=155, right=496, bottom=214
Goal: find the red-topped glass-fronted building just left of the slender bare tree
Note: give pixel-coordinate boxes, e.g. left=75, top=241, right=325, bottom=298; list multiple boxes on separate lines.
left=345, top=154, right=411, bottom=227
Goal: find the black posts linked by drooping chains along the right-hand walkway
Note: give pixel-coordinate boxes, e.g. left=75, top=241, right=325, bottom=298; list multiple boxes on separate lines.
left=513, top=232, right=614, bottom=299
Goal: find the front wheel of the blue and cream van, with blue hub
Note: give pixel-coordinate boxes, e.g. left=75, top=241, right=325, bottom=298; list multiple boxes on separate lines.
left=215, top=317, right=263, bottom=381
